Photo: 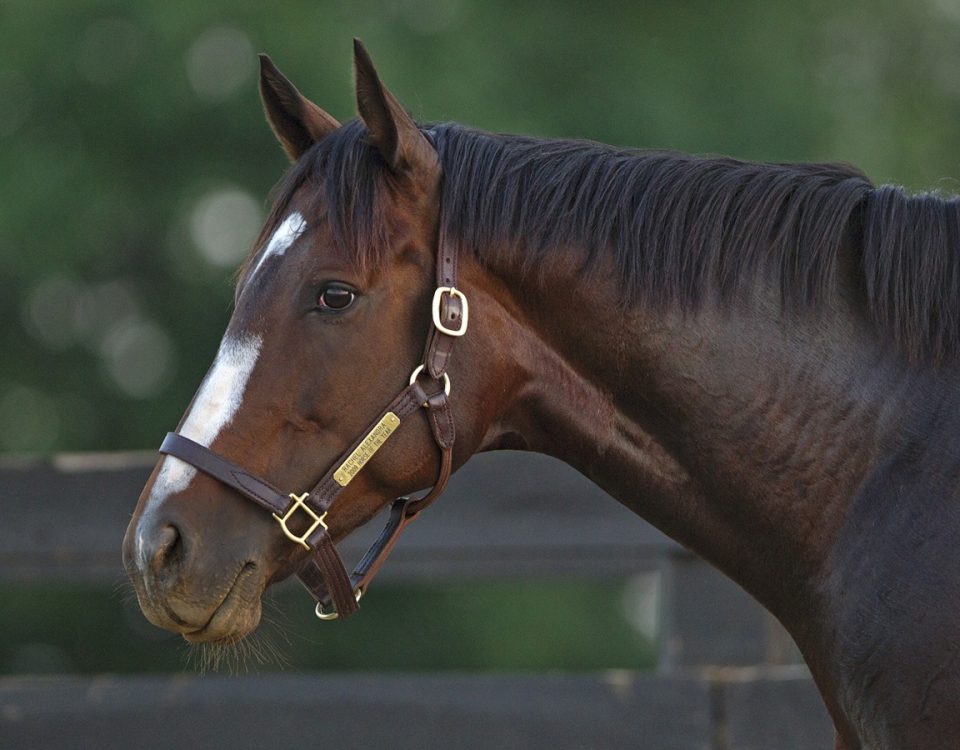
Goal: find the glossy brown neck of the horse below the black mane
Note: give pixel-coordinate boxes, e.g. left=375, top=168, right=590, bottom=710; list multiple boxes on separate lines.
left=476, top=245, right=904, bottom=620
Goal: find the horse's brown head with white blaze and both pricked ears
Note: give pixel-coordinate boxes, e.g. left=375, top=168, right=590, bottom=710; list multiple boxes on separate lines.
left=123, top=42, right=524, bottom=642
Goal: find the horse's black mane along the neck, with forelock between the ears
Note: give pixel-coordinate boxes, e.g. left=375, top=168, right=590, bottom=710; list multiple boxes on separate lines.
left=249, top=120, right=960, bottom=361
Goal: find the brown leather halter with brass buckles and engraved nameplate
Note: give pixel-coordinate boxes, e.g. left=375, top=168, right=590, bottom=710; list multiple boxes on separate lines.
left=160, top=150, right=469, bottom=620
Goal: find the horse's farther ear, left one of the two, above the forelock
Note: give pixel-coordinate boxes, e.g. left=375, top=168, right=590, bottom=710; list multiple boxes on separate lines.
left=260, top=54, right=340, bottom=161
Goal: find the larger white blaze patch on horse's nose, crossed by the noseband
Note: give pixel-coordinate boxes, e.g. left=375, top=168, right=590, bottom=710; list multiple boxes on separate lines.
left=150, top=336, right=263, bottom=500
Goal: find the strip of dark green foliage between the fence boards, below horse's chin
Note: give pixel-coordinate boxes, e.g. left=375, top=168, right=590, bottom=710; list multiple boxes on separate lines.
left=0, top=580, right=656, bottom=675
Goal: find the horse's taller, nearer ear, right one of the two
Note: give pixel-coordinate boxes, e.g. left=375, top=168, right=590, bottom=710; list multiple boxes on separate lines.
left=353, top=39, right=437, bottom=172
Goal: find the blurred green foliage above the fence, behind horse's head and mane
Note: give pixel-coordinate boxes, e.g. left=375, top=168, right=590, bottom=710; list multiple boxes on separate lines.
left=0, top=0, right=960, bottom=452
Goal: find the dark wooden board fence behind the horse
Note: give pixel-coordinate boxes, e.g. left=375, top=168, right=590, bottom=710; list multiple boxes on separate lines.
left=0, top=453, right=832, bottom=750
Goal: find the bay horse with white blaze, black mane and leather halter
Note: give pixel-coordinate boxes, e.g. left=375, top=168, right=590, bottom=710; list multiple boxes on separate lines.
left=123, top=43, right=960, bottom=750
